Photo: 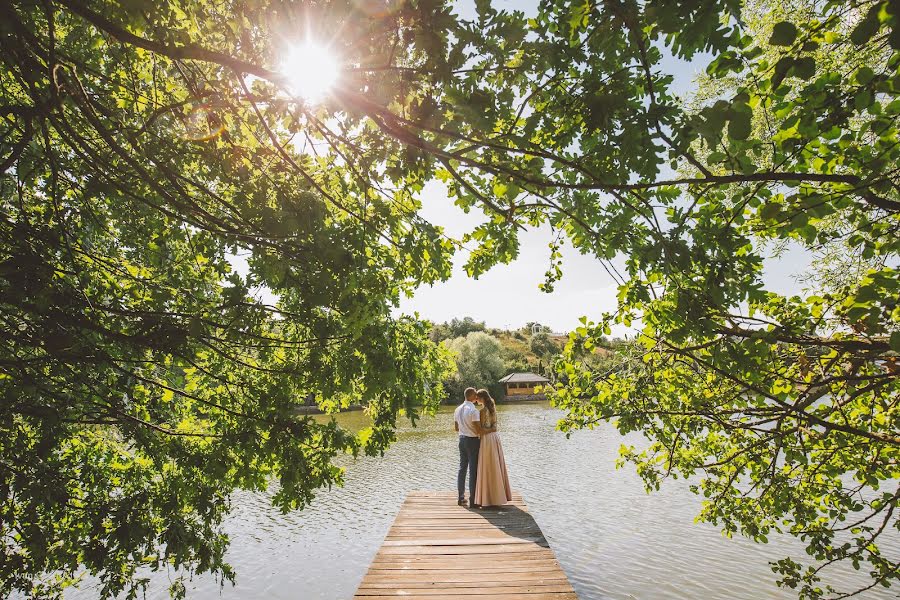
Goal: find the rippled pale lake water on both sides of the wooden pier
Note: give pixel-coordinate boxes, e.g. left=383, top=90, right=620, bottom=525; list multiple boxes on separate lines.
left=67, top=403, right=898, bottom=600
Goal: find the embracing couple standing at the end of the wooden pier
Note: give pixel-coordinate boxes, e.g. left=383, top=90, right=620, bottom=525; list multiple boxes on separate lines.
left=453, top=388, right=512, bottom=508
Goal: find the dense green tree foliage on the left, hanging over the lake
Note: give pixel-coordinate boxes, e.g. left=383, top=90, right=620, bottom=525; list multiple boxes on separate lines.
left=0, top=2, right=458, bottom=598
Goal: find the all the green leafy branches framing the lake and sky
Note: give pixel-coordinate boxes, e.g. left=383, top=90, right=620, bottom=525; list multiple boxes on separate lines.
left=0, top=0, right=900, bottom=598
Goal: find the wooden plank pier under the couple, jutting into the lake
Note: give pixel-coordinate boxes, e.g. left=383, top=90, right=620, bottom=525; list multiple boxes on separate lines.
left=354, top=492, right=577, bottom=600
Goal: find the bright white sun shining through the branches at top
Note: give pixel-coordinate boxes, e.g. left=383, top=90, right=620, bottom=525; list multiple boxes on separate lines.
left=281, top=40, right=340, bottom=103
